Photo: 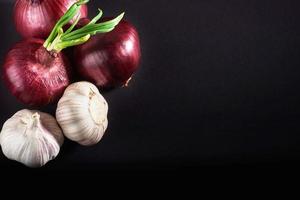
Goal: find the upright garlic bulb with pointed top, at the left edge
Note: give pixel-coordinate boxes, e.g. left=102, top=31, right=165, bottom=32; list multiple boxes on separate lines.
left=0, top=109, right=64, bottom=167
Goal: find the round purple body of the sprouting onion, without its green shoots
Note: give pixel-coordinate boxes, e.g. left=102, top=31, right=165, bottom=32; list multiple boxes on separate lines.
left=2, top=39, right=71, bottom=106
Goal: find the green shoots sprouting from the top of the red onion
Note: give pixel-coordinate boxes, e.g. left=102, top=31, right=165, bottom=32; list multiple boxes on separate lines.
left=43, top=0, right=125, bottom=53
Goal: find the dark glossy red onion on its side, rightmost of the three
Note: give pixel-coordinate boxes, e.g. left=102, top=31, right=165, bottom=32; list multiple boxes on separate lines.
left=74, top=18, right=141, bottom=89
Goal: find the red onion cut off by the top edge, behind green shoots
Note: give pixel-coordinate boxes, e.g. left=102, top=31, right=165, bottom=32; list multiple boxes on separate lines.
left=14, top=0, right=88, bottom=39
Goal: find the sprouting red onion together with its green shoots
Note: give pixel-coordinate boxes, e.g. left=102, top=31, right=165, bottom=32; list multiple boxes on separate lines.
left=2, top=0, right=124, bottom=106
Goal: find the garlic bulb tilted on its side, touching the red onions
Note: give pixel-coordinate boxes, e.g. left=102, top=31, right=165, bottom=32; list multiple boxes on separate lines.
left=56, top=82, right=108, bottom=146
